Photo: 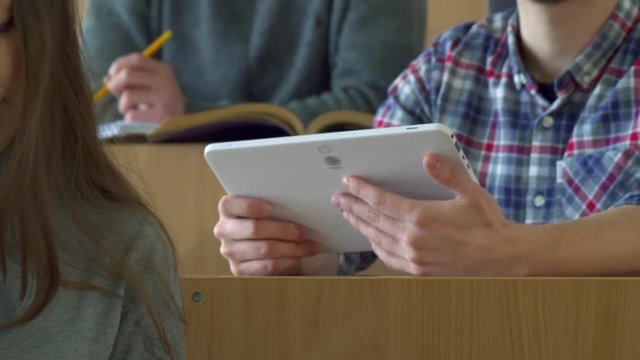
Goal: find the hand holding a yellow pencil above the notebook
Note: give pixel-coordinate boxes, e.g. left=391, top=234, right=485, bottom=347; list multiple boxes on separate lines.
left=94, top=31, right=185, bottom=122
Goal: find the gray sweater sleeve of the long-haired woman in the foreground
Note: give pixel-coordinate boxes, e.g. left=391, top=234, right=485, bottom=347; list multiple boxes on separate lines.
left=110, top=220, right=184, bottom=360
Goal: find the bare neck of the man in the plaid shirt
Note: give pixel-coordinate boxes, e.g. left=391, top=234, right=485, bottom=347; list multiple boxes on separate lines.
left=518, top=0, right=618, bottom=83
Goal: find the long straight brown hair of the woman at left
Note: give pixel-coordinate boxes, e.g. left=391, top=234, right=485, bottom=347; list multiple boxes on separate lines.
left=0, top=0, right=181, bottom=353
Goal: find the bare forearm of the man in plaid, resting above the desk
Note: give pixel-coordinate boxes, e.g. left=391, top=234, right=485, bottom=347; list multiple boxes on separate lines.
left=513, top=206, right=640, bottom=276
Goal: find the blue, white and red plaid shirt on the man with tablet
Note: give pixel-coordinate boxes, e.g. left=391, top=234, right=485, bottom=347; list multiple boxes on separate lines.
left=340, top=0, right=640, bottom=274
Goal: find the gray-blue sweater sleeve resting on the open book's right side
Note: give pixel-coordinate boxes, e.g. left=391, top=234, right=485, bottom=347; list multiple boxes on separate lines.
left=287, top=0, right=426, bottom=124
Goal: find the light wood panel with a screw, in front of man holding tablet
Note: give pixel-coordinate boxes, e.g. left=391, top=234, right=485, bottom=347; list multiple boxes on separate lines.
left=182, top=277, right=640, bottom=360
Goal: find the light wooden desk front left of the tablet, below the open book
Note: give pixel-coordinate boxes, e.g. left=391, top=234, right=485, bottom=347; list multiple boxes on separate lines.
left=107, top=144, right=398, bottom=276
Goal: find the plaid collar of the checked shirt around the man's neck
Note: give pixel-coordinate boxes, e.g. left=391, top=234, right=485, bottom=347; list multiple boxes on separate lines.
left=507, top=0, right=640, bottom=95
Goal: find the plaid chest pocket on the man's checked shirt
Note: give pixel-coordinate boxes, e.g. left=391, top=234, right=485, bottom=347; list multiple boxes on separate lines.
left=556, top=147, right=640, bottom=220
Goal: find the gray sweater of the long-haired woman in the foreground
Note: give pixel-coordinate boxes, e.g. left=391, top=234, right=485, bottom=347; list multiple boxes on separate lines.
left=0, top=169, right=184, bottom=360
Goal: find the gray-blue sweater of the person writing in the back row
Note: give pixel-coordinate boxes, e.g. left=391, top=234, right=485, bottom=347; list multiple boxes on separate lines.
left=84, top=0, right=426, bottom=123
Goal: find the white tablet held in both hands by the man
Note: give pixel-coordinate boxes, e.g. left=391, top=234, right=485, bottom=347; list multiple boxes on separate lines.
left=205, top=124, right=476, bottom=253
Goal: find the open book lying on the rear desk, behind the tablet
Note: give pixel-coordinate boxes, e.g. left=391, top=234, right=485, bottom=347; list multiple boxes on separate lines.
left=98, top=103, right=373, bottom=142
